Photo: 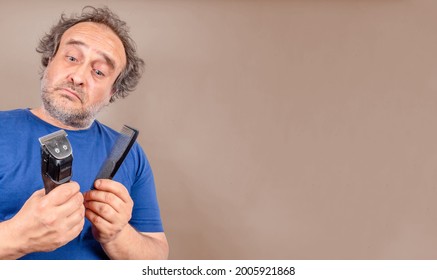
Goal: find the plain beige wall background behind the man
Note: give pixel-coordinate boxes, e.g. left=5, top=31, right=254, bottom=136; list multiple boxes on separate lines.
left=0, top=0, right=437, bottom=259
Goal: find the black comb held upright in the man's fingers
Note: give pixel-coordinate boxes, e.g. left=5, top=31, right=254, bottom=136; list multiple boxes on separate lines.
left=91, top=125, right=139, bottom=189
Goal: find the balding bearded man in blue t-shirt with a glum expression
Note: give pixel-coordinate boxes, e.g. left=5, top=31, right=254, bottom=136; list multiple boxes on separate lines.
left=0, top=7, right=168, bottom=259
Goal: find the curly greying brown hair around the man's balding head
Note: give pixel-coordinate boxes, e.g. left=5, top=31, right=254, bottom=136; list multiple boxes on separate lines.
left=36, top=6, right=144, bottom=102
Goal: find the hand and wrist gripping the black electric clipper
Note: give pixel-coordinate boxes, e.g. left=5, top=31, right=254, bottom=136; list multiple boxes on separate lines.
left=0, top=182, right=85, bottom=259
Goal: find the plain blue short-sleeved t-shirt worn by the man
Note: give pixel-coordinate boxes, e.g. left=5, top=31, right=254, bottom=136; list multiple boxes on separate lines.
left=0, top=109, right=163, bottom=260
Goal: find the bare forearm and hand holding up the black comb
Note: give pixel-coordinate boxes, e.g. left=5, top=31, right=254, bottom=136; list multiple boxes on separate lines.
left=85, top=179, right=168, bottom=259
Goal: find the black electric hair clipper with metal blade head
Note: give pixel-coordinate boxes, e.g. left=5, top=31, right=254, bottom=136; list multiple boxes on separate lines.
left=39, top=129, right=73, bottom=194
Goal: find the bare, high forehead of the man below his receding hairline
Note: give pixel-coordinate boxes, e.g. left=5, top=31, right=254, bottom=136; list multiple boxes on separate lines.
left=60, top=22, right=126, bottom=71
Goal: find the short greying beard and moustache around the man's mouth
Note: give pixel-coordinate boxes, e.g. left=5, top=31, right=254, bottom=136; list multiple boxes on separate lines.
left=41, top=75, right=107, bottom=129
